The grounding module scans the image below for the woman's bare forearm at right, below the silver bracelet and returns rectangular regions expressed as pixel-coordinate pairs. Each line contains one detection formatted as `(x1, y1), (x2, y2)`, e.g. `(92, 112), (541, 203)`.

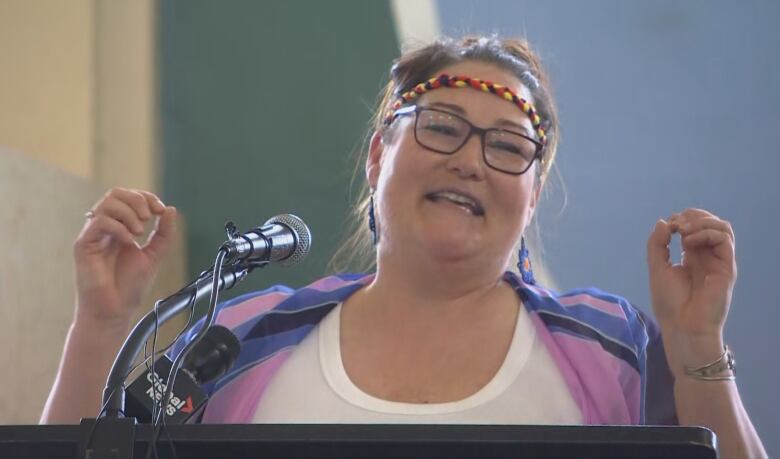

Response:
(674, 375), (768, 459)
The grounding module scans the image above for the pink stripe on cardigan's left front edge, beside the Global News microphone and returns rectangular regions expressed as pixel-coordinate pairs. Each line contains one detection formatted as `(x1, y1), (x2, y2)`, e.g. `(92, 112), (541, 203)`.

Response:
(203, 349), (292, 424)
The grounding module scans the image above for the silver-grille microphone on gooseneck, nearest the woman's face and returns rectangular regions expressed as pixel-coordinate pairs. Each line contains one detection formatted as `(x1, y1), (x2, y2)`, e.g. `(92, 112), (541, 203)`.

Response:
(222, 214), (311, 266)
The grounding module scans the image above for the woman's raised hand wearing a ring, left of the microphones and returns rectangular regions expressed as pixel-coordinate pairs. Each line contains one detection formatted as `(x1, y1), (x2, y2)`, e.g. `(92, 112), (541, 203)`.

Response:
(73, 188), (176, 323)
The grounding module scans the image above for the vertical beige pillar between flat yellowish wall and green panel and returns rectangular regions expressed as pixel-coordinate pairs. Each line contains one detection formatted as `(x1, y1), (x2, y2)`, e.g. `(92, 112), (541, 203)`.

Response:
(94, 0), (161, 190)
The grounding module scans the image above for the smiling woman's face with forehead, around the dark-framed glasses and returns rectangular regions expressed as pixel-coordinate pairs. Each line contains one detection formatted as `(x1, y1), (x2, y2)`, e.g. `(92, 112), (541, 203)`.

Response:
(366, 61), (539, 269)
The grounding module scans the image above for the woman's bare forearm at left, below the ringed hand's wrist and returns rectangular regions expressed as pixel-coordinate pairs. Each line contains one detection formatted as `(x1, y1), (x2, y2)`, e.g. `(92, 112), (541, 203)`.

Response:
(40, 318), (129, 424)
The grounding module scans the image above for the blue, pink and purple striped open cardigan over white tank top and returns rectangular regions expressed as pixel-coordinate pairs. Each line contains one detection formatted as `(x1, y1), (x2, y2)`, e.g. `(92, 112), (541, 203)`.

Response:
(172, 272), (676, 424)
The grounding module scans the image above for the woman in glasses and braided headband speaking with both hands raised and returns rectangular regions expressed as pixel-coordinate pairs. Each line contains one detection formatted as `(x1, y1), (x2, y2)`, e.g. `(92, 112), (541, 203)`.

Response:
(42, 38), (766, 457)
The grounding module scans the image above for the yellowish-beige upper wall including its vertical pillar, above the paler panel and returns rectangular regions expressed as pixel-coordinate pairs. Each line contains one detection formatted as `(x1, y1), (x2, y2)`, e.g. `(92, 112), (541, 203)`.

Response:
(0, 0), (158, 189)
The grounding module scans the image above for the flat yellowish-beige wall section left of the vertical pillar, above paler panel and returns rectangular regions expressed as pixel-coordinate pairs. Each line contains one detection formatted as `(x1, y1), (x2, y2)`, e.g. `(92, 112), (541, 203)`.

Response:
(0, 0), (95, 178)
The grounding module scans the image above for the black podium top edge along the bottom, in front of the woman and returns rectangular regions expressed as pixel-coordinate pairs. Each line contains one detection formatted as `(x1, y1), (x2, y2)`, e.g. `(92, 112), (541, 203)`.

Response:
(0, 424), (717, 459)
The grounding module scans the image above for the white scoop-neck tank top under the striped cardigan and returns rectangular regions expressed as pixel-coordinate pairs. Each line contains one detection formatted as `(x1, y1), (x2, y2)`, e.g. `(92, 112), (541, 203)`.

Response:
(254, 305), (582, 424)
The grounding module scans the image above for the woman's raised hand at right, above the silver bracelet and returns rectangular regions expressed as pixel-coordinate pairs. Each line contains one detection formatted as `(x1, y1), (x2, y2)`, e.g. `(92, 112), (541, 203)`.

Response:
(647, 209), (737, 372)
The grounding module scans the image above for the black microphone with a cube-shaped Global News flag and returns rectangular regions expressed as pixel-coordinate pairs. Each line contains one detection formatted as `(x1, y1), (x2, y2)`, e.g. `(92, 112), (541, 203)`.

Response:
(125, 325), (241, 424)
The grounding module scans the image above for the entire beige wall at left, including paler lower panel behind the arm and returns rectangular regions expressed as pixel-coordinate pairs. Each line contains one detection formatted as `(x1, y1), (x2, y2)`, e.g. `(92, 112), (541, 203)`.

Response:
(0, 0), (185, 424)
